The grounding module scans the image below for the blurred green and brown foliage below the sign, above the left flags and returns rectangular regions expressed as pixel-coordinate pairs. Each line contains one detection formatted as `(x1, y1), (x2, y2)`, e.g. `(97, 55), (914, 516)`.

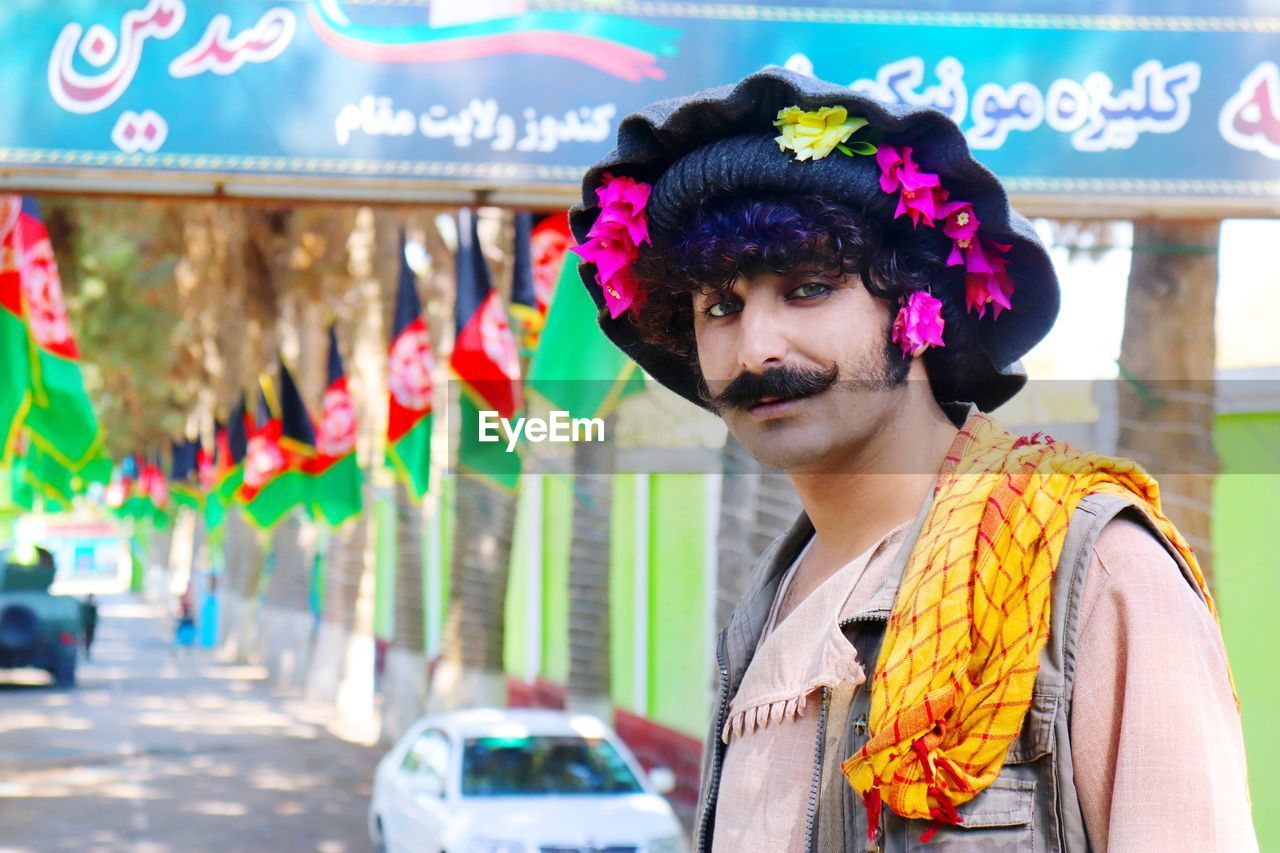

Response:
(41, 197), (355, 459)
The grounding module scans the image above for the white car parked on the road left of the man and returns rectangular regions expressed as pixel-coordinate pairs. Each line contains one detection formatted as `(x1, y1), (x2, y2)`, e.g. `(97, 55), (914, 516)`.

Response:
(369, 708), (687, 853)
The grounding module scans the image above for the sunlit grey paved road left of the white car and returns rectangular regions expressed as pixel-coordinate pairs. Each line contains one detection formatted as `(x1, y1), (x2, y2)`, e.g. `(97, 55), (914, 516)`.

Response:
(0, 598), (380, 853)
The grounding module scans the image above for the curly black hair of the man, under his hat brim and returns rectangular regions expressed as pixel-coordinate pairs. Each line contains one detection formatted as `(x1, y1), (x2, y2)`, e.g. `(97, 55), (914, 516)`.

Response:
(632, 195), (989, 402)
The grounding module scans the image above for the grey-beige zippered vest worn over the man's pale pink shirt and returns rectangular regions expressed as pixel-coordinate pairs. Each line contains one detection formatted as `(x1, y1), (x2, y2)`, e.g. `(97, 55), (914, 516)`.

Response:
(694, 468), (1194, 853)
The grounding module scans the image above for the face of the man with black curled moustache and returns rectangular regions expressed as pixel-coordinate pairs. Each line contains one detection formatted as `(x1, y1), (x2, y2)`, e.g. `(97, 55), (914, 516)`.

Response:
(692, 270), (920, 473)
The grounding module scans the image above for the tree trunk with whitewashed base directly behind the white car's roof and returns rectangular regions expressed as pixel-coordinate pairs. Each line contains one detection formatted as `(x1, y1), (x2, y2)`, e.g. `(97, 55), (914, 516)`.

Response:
(428, 473), (516, 711)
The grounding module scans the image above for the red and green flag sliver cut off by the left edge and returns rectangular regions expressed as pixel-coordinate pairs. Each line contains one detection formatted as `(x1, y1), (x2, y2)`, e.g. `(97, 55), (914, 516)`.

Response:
(0, 196), (31, 465)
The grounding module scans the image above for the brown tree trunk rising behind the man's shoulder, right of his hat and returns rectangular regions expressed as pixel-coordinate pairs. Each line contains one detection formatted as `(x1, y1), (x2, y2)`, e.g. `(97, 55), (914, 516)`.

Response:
(1119, 220), (1221, 576)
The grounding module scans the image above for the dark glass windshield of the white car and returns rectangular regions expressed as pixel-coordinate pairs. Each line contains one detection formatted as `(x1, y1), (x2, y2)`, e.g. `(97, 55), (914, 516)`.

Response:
(462, 735), (643, 797)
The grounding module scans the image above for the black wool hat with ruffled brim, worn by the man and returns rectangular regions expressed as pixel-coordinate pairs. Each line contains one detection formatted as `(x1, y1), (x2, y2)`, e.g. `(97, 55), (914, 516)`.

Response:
(570, 67), (1059, 411)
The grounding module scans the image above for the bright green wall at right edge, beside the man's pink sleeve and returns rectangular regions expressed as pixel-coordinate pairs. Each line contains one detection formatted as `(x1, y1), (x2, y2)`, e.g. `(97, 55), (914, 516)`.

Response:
(1212, 414), (1280, 850)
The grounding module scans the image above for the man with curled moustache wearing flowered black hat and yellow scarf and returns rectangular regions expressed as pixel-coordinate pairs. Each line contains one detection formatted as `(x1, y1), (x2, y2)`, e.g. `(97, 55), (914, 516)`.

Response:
(571, 68), (1257, 852)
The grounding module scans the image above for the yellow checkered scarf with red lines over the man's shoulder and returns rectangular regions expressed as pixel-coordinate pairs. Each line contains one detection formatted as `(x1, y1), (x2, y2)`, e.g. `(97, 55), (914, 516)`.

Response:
(842, 414), (1217, 835)
